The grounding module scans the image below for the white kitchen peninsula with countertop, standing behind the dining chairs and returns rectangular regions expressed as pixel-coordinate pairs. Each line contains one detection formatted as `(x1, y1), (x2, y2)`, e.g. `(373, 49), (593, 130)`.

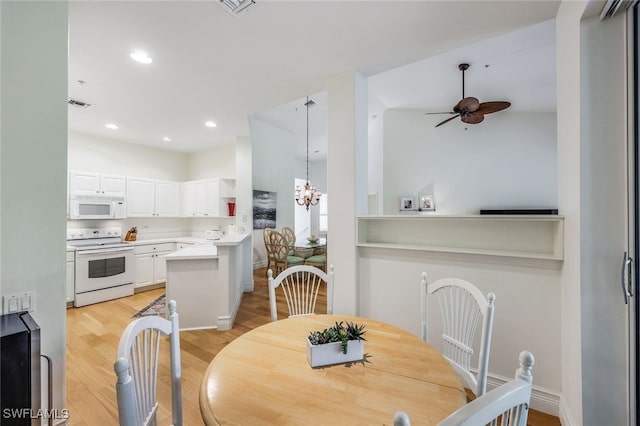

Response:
(166, 234), (253, 330)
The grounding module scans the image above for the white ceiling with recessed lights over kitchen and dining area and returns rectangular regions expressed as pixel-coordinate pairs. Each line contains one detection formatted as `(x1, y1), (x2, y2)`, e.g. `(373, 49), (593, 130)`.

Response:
(69, 0), (559, 152)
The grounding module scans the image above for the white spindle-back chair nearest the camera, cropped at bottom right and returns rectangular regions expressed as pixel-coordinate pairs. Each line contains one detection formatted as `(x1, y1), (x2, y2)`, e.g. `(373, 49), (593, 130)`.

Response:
(393, 351), (534, 426)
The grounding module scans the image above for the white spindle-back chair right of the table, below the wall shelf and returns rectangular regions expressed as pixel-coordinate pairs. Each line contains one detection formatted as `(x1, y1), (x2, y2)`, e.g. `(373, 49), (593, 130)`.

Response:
(420, 272), (496, 397)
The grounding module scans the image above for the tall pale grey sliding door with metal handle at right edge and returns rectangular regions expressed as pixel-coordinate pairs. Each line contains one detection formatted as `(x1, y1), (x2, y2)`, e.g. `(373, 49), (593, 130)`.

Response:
(580, 10), (635, 426)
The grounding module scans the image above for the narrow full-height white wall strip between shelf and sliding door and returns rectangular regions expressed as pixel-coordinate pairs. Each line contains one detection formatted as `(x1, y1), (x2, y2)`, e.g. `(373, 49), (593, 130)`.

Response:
(556, 1), (586, 426)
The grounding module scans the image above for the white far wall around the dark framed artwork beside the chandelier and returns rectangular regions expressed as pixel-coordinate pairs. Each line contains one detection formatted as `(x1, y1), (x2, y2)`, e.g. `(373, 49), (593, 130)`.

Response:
(249, 117), (296, 266)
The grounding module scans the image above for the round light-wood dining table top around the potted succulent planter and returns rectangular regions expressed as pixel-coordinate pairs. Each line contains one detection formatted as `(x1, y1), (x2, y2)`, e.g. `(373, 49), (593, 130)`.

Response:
(200, 315), (467, 425)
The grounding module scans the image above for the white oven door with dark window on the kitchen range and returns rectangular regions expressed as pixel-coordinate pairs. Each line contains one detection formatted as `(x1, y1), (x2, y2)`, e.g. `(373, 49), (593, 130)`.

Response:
(76, 247), (134, 293)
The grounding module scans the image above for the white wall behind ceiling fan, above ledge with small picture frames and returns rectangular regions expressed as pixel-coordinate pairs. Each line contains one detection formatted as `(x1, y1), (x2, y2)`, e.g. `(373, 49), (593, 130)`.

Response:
(383, 109), (558, 214)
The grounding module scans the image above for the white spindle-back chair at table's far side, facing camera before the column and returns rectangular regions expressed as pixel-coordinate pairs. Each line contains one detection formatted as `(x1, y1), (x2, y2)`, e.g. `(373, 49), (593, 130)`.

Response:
(267, 265), (334, 321)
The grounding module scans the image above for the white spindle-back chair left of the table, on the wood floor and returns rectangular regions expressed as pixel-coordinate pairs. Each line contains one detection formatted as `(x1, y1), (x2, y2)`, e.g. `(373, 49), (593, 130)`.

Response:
(114, 300), (182, 426)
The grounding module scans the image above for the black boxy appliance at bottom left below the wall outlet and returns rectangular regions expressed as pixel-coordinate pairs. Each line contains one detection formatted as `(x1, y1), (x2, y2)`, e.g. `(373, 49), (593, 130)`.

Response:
(0, 312), (40, 426)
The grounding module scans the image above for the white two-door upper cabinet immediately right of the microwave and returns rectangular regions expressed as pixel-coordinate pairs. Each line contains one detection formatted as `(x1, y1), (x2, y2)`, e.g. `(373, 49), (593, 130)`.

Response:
(127, 178), (180, 217)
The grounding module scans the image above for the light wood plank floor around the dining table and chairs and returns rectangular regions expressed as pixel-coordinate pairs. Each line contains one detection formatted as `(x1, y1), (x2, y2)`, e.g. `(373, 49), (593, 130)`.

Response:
(66, 269), (560, 426)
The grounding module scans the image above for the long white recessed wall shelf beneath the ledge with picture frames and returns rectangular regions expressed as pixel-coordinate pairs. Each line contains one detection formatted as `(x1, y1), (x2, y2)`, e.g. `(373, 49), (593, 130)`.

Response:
(356, 214), (564, 261)
